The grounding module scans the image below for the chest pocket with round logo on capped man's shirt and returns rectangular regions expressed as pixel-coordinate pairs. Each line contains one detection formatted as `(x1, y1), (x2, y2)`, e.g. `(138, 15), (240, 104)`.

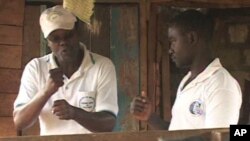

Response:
(79, 92), (96, 112)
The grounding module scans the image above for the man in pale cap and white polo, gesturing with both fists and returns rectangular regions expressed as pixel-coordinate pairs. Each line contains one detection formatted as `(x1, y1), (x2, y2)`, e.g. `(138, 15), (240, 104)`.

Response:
(13, 6), (118, 135)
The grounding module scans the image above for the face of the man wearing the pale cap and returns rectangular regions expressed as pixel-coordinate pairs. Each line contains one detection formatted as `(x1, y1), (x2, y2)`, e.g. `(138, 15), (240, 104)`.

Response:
(47, 29), (79, 62)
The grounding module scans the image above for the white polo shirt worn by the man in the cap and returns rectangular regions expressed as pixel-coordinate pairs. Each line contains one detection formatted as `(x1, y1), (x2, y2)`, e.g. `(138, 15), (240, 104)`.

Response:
(14, 44), (118, 135)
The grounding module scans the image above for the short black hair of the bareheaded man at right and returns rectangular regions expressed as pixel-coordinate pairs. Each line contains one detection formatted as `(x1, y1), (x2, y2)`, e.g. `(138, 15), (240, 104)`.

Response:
(168, 9), (214, 42)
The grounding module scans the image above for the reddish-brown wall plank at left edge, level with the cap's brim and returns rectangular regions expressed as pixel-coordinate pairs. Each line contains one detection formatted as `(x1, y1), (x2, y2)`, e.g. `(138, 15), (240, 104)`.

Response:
(0, 25), (23, 45)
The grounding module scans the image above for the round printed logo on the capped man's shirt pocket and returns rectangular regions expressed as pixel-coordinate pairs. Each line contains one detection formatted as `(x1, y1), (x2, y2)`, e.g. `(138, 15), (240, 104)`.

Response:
(79, 96), (95, 112)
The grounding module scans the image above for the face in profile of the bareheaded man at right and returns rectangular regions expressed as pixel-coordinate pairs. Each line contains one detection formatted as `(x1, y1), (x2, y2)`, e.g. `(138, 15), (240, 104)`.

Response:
(168, 27), (194, 68)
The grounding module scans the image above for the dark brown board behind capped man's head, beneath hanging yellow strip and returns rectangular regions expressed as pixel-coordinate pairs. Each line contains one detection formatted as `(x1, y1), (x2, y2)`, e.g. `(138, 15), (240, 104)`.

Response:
(80, 4), (110, 57)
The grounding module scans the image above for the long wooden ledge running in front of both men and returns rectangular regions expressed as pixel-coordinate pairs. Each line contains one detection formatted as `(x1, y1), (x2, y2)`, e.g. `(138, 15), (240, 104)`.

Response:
(0, 129), (229, 141)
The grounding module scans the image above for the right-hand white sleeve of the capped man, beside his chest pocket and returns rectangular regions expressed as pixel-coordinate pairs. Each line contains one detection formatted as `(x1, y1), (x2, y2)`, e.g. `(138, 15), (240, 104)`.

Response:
(95, 60), (118, 116)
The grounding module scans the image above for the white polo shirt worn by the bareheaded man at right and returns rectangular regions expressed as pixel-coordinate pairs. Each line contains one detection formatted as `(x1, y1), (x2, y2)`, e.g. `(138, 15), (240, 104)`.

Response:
(169, 58), (242, 130)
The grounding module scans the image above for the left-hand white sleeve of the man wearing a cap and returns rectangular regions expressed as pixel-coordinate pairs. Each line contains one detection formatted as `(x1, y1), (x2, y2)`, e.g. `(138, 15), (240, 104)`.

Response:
(14, 60), (38, 109)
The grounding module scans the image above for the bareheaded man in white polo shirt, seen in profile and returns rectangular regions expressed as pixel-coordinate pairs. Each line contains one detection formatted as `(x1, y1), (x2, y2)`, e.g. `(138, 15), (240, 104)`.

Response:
(131, 10), (242, 130)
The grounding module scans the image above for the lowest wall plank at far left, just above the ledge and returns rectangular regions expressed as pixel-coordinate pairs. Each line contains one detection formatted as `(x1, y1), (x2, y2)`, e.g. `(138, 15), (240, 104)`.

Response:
(0, 117), (16, 137)
